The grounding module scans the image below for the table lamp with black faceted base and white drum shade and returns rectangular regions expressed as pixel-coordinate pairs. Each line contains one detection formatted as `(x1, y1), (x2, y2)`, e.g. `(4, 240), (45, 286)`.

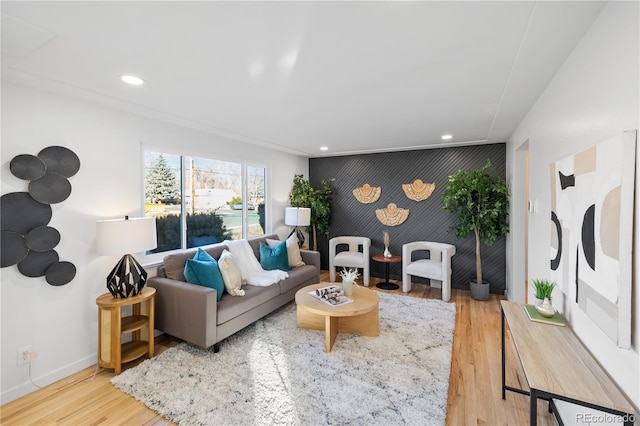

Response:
(96, 216), (158, 299)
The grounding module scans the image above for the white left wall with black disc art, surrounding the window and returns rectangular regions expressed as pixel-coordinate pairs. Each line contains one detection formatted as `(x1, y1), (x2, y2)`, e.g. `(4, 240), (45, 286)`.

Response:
(0, 83), (308, 404)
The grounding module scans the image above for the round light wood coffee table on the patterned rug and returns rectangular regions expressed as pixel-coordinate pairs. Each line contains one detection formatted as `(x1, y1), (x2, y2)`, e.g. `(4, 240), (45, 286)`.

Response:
(296, 283), (380, 352)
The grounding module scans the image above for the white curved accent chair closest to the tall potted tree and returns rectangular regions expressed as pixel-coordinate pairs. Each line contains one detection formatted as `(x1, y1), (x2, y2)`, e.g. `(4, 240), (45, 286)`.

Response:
(402, 241), (456, 302)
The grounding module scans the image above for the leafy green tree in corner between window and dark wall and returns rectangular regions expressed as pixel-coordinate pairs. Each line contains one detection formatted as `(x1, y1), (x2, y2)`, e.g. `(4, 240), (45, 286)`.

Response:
(289, 175), (335, 250)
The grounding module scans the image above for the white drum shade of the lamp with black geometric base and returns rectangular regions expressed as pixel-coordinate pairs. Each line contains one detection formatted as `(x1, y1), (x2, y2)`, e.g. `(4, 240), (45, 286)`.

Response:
(96, 217), (158, 256)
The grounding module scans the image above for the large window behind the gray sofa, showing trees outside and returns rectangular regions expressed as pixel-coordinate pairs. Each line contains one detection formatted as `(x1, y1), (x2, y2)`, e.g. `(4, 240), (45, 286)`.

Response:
(144, 151), (266, 253)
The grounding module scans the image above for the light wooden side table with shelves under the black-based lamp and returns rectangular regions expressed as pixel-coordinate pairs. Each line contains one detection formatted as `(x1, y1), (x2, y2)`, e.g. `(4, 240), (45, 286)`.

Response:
(96, 287), (156, 374)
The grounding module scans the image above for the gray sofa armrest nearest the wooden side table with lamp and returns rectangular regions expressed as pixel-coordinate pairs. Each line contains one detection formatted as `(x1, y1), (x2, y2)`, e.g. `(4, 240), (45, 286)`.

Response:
(147, 277), (218, 348)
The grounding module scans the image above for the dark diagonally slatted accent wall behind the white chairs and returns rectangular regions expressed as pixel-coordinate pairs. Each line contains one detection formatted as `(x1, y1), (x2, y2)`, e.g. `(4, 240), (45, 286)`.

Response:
(309, 144), (506, 294)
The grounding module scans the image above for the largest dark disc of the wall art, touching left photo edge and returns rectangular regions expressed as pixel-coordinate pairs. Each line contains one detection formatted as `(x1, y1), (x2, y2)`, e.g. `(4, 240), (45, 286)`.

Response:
(0, 192), (52, 235)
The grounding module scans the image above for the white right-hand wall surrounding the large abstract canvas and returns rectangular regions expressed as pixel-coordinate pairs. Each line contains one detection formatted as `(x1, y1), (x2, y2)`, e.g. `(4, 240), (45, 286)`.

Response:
(507, 1), (640, 405)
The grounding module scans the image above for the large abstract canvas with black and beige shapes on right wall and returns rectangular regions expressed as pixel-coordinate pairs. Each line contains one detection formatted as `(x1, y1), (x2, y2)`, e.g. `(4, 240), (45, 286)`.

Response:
(550, 131), (637, 348)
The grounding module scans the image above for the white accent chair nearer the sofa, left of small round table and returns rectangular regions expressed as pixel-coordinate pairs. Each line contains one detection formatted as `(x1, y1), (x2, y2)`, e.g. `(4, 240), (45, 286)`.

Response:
(329, 237), (371, 287)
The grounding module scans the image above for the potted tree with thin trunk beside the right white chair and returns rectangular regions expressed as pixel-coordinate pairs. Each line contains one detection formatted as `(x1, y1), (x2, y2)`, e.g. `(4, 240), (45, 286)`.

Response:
(442, 161), (509, 300)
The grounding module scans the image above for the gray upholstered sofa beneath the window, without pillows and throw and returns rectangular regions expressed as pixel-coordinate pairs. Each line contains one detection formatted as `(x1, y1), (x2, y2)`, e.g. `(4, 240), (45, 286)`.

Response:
(147, 235), (320, 352)
